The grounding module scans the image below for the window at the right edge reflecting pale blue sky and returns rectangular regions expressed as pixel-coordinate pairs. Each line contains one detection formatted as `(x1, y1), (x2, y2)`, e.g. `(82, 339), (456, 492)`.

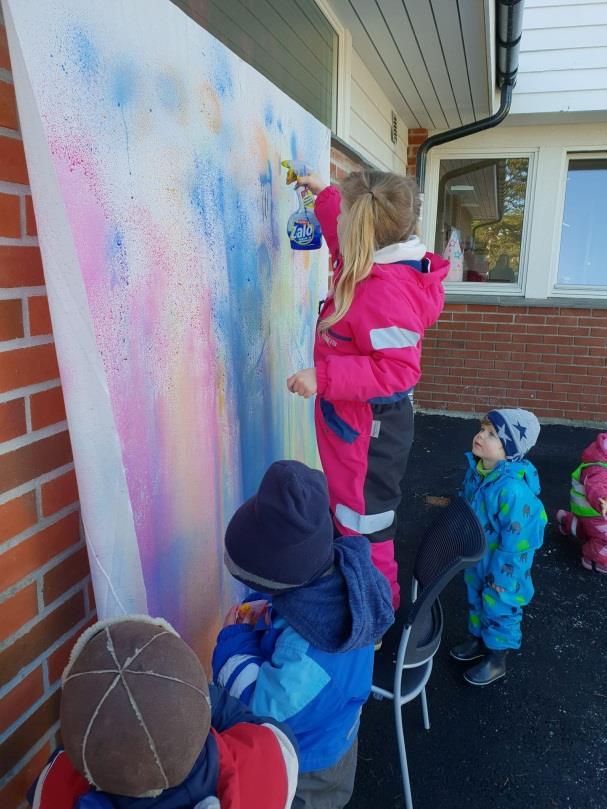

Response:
(557, 157), (607, 289)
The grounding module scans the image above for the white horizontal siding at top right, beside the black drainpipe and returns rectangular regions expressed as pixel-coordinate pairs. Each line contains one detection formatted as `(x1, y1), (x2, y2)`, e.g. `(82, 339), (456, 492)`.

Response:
(512, 0), (607, 115)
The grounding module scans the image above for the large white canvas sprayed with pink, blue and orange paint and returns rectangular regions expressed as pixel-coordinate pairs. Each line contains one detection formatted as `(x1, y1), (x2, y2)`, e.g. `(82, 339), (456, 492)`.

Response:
(3, 0), (330, 656)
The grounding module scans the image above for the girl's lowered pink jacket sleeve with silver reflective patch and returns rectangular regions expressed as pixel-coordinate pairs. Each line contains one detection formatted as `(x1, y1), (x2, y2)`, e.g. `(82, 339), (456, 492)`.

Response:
(316, 279), (424, 402)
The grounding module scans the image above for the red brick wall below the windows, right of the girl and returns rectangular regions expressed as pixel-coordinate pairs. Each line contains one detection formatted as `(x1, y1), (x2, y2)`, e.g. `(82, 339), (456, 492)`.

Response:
(415, 303), (607, 425)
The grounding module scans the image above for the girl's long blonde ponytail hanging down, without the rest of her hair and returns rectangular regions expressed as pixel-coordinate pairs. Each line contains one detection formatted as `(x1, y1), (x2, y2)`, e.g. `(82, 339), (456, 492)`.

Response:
(318, 191), (376, 331)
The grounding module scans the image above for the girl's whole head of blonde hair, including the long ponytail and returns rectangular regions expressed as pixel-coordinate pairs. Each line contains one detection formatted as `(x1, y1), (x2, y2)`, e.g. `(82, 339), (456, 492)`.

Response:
(318, 170), (421, 331)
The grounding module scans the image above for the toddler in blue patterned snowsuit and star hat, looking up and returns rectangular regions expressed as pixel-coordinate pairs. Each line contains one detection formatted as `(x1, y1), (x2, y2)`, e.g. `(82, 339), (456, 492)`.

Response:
(451, 408), (547, 685)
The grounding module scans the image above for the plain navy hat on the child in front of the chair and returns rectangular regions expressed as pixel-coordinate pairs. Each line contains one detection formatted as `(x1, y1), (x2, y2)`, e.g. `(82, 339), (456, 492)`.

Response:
(225, 461), (333, 593)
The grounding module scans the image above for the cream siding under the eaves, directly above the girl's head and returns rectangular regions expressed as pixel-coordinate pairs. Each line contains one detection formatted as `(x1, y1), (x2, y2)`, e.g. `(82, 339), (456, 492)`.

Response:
(347, 50), (407, 173)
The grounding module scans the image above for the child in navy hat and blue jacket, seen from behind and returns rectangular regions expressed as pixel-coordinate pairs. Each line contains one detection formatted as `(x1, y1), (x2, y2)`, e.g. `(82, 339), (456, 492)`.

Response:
(213, 461), (394, 809)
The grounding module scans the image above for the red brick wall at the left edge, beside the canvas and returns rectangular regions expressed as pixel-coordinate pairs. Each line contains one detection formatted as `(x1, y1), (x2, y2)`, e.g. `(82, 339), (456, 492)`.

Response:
(0, 26), (94, 809)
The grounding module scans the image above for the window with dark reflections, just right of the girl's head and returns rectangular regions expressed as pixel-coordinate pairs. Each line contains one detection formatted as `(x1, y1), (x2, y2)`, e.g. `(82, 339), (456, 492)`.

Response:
(434, 157), (529, 291)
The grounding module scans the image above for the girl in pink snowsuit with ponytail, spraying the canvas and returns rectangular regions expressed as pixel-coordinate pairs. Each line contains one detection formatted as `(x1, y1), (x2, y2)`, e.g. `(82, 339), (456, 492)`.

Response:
(287, 171), (449, 608)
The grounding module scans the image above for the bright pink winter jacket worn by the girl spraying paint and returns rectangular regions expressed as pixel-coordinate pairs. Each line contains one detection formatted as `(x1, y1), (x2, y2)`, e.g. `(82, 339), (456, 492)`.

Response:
(314, 186), (449, 402)
